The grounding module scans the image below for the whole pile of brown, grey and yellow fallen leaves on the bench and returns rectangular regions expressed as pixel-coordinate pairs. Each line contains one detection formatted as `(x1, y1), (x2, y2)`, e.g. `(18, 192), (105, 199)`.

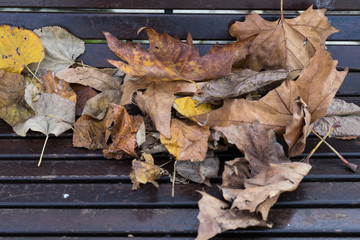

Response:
(0, 7), (360, 239)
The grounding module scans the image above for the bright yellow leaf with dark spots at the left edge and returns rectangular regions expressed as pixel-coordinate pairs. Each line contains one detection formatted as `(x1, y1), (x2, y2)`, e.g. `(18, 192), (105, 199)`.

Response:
(0, 25), (45, 74)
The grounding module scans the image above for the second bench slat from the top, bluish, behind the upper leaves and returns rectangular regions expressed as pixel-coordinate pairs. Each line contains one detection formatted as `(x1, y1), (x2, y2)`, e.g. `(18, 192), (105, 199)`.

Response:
(0, 12), (360, 41)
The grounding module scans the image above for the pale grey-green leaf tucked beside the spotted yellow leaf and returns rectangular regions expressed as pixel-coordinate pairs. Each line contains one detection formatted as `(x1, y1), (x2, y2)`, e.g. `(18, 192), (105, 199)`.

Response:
(30, 26), (85, 73)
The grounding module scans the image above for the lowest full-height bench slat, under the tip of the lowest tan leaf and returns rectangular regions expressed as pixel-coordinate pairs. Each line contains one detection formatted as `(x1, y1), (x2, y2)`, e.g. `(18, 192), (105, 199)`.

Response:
(0, 208), (360, 237)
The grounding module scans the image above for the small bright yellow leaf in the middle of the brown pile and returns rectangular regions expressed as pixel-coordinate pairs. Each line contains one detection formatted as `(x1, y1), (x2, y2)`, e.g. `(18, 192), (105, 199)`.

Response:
(174, 97), (215, 117)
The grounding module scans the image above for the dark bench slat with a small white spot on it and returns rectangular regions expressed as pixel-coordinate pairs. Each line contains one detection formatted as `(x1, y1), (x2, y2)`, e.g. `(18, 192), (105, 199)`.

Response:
(0, 182), (360, 208)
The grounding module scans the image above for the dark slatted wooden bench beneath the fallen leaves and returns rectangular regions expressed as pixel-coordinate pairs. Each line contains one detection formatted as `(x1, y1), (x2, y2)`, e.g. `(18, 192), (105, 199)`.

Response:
(0, 0), (360, 240)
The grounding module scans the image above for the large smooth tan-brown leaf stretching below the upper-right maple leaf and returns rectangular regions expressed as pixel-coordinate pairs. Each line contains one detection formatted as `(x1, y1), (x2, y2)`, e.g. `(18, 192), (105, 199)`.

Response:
(194, 47), (347, 158)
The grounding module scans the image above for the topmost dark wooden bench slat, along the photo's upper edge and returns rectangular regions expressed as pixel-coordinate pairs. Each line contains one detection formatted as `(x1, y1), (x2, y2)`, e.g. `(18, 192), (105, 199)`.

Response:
(0, 0), (360, 10)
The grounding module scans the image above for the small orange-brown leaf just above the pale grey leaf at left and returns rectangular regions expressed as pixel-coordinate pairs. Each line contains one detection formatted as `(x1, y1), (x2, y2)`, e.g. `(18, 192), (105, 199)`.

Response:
(41, 71), (76, 104)
